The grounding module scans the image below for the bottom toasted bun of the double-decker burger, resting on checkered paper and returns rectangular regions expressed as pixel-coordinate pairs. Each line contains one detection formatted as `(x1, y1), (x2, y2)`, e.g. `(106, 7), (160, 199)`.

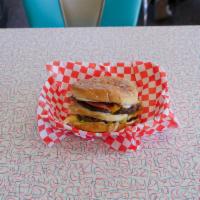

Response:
(64, 115), (138, 133)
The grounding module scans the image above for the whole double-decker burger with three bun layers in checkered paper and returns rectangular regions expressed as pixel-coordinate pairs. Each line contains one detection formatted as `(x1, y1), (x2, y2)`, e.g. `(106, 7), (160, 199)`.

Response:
(65, 76), (141, 133)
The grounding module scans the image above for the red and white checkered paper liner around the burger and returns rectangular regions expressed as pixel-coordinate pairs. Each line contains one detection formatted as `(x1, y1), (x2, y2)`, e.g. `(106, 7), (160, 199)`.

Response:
(37, 61), (178, 152)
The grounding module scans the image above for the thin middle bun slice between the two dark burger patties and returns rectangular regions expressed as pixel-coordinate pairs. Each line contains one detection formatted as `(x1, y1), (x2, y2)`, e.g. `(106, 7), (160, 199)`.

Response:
(69, 103), (128, 122)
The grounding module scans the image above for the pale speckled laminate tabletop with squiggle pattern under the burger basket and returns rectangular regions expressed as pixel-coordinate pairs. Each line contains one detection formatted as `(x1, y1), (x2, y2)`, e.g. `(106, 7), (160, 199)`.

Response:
(0, 26), (200, 200)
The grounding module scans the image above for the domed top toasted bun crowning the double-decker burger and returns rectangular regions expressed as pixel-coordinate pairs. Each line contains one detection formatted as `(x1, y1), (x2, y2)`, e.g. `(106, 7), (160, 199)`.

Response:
(72, 76), (138, 106)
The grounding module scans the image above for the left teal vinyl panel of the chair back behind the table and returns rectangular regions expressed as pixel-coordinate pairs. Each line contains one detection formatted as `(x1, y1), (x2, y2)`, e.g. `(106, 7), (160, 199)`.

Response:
(23, 0), (65, 28)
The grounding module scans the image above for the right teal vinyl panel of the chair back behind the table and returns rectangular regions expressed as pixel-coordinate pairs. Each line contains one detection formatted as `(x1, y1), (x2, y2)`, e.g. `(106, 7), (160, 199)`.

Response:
(99, 0), (142, 26)
